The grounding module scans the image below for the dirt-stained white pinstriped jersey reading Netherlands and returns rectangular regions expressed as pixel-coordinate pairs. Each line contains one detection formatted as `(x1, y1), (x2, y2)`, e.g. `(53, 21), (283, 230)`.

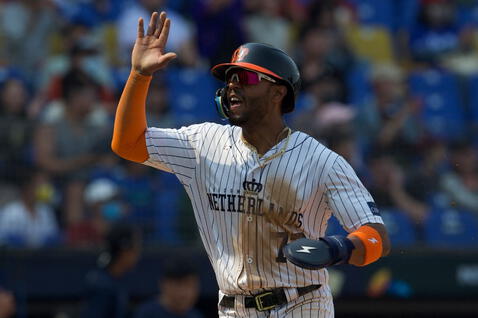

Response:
(144, 123), (383, 296)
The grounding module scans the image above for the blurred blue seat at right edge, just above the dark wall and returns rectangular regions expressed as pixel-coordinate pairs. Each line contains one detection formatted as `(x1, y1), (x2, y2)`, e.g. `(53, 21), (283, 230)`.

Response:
(425, 208), (478, 248)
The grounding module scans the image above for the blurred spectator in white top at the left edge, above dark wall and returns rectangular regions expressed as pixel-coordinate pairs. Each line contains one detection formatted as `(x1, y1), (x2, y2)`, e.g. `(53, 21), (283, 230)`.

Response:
(0, 167), (60, 247)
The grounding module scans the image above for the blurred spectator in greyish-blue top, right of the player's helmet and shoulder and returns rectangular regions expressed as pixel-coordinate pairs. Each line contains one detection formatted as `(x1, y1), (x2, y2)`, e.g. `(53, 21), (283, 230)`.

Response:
(356, 64), (423, 162)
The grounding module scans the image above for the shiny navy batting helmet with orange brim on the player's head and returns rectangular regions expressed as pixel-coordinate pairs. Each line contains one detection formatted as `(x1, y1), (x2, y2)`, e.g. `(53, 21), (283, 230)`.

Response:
(211, 43), (300, 113)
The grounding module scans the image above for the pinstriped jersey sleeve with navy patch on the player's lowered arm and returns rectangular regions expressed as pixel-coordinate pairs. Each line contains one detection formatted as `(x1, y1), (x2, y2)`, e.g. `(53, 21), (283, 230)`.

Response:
(325, 156), (383, 232)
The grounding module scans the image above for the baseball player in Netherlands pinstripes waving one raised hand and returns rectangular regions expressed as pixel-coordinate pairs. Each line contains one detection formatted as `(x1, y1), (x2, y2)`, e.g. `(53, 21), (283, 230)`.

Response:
(112, 12), (390, 317)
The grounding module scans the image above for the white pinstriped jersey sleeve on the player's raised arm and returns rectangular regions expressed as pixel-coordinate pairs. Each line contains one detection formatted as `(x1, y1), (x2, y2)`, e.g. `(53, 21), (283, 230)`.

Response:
(143, 124), (203, 184)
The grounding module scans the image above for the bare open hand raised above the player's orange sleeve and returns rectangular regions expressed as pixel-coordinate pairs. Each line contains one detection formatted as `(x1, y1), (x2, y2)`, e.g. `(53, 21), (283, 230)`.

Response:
(131, 12), (176, 75)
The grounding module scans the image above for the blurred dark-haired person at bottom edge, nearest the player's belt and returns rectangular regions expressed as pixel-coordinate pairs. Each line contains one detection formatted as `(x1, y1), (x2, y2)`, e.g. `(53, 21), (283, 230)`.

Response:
(135, 255), (203, 318)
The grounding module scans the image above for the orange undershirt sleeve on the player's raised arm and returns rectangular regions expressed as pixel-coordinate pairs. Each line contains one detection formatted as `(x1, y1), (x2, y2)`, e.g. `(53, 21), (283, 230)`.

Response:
(111, 70), (152, 162)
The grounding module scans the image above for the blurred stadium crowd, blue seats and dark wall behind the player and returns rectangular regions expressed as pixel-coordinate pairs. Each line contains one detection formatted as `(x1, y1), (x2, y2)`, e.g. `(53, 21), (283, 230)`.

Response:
(0, 0), (478, 318)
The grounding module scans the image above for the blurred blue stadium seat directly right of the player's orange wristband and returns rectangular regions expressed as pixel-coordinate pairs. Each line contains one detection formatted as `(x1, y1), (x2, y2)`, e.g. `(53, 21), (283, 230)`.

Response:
(381, 209), (417, 246)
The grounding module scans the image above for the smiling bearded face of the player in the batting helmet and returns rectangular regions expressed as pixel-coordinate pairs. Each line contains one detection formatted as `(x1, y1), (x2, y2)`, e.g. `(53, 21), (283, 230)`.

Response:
(226, 69), (274, 127)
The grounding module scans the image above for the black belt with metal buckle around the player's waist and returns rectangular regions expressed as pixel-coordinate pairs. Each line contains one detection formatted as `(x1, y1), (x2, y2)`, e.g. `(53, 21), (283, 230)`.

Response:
(219, 285), (321, 311)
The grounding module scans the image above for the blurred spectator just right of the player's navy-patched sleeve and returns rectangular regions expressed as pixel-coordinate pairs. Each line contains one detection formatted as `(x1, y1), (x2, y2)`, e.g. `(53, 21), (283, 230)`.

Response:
(365, 149), (429, 229)
